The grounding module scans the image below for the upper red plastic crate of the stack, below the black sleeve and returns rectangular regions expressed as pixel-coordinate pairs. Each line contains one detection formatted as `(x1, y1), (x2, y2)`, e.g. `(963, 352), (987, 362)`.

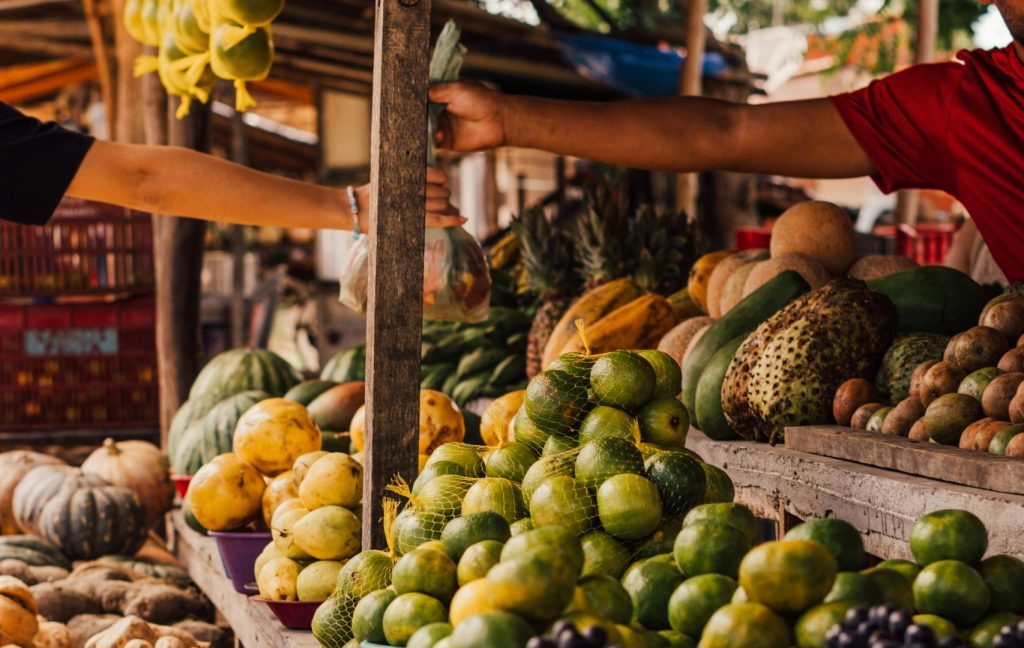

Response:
(0, 198), (154, 298)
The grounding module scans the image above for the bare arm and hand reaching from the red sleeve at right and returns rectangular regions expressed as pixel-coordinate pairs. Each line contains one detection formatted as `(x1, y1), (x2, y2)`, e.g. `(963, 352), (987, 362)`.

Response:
(430, 83), (873, 178)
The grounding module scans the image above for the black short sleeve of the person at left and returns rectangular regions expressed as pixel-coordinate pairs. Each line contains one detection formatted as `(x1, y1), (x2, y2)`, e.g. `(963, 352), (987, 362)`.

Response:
(0, 101), (93, 225)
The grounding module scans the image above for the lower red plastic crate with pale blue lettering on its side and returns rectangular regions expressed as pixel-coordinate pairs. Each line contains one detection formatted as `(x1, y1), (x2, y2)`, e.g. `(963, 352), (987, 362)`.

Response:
(0, 297), (160, 431)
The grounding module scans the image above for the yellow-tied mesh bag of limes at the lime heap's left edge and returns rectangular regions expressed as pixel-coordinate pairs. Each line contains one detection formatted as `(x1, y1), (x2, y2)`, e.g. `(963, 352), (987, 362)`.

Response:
(311, 499), (398, 648)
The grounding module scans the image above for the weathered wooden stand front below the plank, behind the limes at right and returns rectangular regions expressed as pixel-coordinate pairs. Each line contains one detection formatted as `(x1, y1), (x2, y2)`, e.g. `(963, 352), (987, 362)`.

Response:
(686, 428), (1024, 558)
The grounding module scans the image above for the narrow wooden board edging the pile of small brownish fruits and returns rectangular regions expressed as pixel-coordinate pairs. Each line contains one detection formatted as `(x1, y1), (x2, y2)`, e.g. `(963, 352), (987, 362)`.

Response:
(785, 426), (1024, 494)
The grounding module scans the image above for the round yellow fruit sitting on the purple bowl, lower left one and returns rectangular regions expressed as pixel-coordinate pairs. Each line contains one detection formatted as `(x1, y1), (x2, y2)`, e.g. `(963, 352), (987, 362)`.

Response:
(185, 452), (266, 531)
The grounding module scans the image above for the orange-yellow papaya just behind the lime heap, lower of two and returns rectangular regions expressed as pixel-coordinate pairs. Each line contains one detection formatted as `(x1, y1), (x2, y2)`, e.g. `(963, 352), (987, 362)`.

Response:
(559, 295), (677, 355)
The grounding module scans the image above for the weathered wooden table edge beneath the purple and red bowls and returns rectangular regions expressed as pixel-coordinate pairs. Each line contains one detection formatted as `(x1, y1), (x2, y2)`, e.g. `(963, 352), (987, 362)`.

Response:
(167, 510), (319, 648)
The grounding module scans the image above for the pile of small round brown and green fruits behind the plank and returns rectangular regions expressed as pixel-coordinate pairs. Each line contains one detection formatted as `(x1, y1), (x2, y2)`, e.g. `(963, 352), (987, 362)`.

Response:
(833, 284), (1024, 457)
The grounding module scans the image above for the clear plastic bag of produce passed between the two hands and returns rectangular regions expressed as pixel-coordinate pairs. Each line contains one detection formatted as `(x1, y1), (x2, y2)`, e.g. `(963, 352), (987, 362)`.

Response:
(340, 20), (490, 323)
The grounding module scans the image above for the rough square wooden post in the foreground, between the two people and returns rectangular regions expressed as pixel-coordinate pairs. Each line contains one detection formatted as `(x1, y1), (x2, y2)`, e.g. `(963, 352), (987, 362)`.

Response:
(362, 0), (430, 549)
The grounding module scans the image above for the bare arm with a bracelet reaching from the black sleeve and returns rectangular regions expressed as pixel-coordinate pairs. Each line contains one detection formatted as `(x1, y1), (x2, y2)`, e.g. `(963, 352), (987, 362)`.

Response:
(67, 141), (464, 231)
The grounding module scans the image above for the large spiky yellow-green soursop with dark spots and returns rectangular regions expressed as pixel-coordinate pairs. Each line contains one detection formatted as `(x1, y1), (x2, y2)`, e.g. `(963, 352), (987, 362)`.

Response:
(722, 278), (896, 441)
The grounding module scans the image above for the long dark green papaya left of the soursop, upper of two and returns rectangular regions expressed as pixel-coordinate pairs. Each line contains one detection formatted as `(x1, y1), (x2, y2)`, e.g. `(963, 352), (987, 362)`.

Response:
(682, 270), (810, 412)
